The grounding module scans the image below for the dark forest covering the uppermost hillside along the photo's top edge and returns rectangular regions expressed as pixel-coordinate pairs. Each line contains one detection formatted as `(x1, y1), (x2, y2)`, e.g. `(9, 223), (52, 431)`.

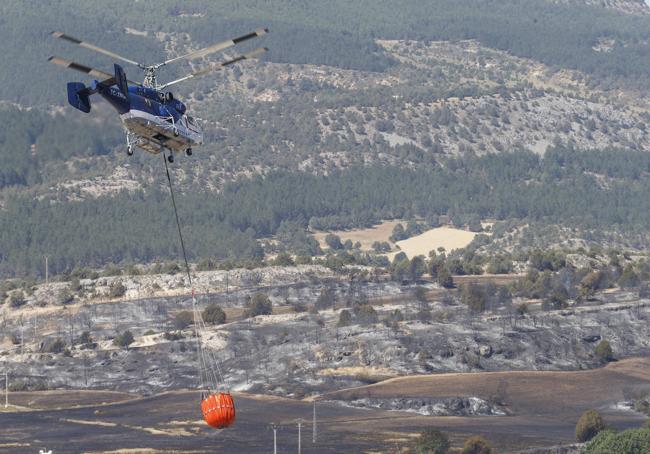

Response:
(0, 0), (650, 104)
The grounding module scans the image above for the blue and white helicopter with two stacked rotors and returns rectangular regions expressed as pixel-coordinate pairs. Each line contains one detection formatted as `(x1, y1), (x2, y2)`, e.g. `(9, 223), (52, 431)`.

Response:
(48, 28), (268, 163)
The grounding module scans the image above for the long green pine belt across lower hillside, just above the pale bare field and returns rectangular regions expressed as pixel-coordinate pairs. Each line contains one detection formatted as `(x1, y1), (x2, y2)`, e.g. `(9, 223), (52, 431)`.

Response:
(0, 147), (650, 276)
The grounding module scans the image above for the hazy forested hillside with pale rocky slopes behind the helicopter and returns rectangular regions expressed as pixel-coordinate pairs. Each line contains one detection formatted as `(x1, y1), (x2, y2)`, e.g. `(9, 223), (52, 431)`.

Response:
(0, 0), (650, 276)
